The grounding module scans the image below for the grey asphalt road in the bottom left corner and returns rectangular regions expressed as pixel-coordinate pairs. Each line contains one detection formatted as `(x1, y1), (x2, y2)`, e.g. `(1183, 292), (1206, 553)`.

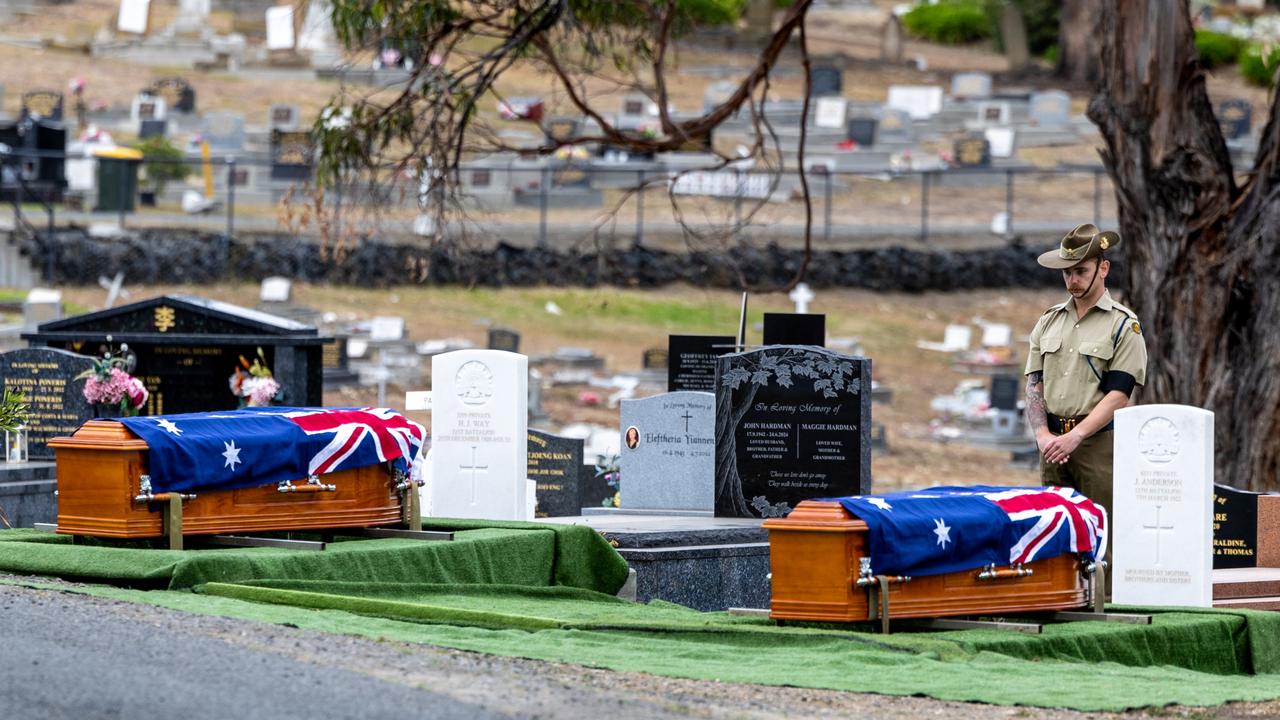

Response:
(0, 589), (507, 720)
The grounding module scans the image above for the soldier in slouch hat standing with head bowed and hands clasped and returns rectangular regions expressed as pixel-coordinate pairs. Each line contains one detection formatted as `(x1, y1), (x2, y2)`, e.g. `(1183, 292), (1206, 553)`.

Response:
(1027, 223), (1147, 520)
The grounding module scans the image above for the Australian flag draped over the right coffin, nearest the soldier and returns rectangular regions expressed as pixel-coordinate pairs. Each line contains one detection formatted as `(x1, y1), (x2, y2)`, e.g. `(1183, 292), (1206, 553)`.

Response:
(831, 486), (1107, 575)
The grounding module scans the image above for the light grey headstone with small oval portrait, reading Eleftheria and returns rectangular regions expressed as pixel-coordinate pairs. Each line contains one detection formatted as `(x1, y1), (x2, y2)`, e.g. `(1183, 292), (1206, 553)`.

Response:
(620, 392), (716, 512)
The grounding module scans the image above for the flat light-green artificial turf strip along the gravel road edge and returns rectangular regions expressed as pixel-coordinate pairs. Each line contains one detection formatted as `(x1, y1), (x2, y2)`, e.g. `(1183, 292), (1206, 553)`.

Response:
(10, 573), (1280, 711)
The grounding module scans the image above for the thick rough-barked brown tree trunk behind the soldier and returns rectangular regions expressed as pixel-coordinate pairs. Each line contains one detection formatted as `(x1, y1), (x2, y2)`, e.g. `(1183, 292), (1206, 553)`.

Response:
(1090, 0), (1280, 489)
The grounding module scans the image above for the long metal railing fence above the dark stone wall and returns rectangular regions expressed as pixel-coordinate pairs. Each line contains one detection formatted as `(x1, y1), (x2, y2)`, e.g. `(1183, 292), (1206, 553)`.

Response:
(0, 151), (1116, 249)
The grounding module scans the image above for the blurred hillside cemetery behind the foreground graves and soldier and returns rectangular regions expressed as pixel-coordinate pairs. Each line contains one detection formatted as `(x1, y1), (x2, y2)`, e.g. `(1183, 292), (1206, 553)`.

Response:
(0, 0), (1264, 489)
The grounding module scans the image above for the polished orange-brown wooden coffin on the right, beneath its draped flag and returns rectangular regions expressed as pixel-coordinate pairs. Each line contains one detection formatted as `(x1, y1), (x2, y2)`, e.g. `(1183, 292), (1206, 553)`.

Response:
(764, 500), (1088, 623)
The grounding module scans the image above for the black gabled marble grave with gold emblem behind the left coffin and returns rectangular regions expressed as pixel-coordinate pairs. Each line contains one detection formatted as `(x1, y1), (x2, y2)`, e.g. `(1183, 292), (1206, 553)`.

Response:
(22, 295), (333, 415)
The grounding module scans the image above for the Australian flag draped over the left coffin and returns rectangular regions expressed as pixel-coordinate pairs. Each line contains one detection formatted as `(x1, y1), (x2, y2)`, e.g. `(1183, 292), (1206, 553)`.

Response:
(120, 407), (426, 492)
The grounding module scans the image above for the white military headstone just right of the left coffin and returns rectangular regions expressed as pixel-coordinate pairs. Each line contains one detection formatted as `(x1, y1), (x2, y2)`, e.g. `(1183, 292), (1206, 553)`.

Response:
(425, 350), (532, 520)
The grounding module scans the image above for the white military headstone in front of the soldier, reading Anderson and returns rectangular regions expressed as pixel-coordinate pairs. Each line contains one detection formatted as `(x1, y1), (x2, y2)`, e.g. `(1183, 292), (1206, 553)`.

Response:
(1108, 405), (1213, 607)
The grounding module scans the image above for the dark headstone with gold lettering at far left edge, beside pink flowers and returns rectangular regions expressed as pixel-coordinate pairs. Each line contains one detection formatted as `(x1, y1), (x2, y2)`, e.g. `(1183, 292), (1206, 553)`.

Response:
(0, 347), (93, 460)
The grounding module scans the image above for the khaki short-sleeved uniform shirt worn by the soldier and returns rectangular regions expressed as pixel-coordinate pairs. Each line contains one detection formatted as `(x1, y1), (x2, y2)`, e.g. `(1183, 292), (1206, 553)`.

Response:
(1027, 292), (1147, 418)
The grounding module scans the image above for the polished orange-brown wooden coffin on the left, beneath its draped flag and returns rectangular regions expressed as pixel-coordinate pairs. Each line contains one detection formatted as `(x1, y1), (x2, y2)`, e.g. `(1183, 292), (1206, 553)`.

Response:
(49, 420), (416, 538)
